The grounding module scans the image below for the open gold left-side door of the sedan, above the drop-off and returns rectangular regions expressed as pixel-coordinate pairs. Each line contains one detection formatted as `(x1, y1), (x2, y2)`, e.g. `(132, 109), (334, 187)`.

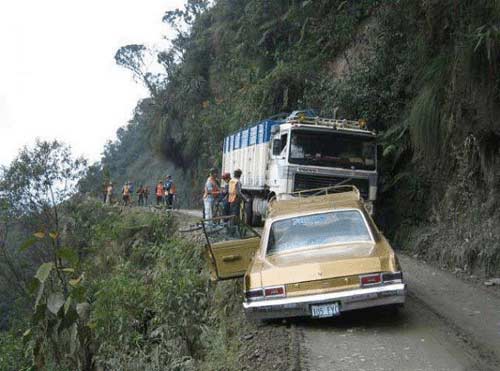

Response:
(203, 220), (260, 280)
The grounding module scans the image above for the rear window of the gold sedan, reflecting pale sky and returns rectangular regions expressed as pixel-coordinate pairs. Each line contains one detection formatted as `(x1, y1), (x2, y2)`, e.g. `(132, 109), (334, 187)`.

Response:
(267, 210), (372, 255)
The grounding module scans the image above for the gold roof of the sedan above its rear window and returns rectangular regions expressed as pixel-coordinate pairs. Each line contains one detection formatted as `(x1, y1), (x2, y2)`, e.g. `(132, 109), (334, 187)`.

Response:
(268, 187), (364, 219)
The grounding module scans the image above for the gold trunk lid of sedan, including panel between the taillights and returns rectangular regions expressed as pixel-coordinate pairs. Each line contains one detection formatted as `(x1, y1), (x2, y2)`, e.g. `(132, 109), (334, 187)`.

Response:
(261, 243), (389, 296)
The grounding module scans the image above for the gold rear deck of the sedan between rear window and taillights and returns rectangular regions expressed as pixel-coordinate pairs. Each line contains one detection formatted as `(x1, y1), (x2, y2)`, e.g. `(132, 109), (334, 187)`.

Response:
(260, 243), (391, 286)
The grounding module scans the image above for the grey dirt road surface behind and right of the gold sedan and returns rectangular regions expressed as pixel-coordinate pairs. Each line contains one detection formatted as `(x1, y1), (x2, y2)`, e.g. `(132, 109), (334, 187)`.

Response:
(296, 256), (500, 371)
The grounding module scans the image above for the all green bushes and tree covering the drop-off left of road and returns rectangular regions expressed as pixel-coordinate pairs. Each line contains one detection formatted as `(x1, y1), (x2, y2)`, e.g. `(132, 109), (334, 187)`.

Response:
(0, 142), (247, 370)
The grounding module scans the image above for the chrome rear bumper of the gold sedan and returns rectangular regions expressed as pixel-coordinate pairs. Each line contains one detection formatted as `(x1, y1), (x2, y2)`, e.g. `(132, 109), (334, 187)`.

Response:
(243, 283), (406, 320)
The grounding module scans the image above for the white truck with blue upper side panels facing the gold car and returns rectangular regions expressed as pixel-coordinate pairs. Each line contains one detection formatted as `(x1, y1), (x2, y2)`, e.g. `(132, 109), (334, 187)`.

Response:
(222, 111), (378, 224)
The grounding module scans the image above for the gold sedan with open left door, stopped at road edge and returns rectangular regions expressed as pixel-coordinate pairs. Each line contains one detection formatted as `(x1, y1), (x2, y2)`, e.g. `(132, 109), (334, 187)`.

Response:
(205, 187), (406, 319)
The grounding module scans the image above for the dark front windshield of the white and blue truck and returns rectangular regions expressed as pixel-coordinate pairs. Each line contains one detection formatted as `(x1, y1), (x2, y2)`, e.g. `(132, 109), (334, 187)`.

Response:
(289, 130), (376, 170)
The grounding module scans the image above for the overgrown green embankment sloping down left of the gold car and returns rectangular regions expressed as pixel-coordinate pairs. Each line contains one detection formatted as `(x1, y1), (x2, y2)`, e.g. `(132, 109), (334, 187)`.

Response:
(0, 199), (298, 371)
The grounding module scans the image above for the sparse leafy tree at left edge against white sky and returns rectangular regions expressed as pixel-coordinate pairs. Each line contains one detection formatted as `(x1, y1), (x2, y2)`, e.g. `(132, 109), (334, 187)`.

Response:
(0, 140), (86, 304)
